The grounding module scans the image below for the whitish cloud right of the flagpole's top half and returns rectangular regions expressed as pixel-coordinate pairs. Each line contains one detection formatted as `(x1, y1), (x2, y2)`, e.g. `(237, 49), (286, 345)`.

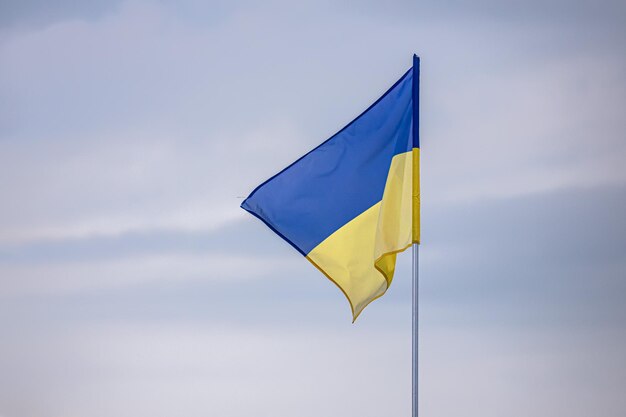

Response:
(422, 43), (626, 203)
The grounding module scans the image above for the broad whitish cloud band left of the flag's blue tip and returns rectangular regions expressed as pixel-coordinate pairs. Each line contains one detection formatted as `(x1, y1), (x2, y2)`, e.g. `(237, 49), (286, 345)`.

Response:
(0, 118), (299, 243)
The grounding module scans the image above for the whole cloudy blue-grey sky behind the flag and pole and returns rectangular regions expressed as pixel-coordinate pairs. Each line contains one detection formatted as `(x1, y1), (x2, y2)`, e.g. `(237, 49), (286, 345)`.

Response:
(0, 0), (626, 417)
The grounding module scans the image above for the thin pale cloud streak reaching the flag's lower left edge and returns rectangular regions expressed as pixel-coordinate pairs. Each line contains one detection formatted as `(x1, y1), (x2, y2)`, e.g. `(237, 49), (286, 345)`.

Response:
(0, 253), (303, 297)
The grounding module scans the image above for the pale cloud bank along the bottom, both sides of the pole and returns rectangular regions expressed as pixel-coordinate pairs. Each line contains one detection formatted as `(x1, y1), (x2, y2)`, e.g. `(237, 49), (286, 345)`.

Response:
(0, 316), (626, 417)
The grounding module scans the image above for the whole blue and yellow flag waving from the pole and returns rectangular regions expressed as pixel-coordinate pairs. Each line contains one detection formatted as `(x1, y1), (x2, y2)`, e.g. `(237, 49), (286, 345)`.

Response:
(241, 56), (420, 320)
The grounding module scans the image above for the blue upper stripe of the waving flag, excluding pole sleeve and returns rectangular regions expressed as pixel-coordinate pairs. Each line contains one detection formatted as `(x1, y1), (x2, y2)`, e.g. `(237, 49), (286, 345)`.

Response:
(241, 69), (413, 255)
